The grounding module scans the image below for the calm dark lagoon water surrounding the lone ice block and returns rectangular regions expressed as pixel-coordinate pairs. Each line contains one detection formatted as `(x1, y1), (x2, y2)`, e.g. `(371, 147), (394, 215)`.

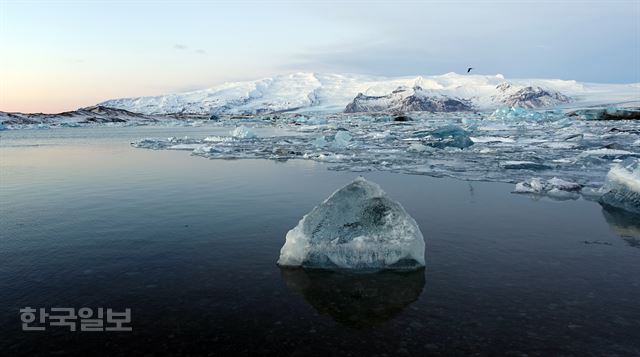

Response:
(0, 128), (640, 356)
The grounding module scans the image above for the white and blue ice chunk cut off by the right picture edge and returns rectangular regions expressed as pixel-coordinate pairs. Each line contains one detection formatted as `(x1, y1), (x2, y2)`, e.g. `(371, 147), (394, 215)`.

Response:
(600, 159), (640, 213)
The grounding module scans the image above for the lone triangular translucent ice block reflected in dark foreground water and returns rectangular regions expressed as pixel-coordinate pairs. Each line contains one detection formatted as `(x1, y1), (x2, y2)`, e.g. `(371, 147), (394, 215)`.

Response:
(278, 177), (425, 270)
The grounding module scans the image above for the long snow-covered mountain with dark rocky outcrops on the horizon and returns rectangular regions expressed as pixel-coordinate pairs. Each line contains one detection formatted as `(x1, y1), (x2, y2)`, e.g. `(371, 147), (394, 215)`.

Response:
(100, 73), (640, 114)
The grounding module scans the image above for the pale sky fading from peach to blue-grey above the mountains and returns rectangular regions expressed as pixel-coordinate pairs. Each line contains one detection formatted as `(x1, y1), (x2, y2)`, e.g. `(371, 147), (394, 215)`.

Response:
(0, 0), (640, 112)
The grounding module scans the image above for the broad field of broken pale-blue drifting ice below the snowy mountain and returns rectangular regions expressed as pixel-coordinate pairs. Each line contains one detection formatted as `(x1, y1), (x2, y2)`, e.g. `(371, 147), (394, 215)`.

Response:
(132, 111), (640, 188)
